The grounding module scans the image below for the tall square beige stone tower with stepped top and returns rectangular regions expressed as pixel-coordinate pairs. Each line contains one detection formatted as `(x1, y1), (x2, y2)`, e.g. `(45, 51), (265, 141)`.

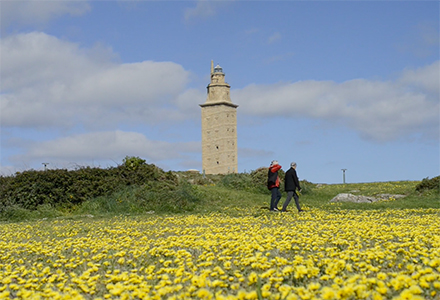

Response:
(200, 61), (238, 174)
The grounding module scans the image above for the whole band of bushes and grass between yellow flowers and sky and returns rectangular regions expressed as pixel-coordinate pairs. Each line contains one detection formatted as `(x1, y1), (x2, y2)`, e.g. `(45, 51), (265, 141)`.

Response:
(0, 157), (440, 221)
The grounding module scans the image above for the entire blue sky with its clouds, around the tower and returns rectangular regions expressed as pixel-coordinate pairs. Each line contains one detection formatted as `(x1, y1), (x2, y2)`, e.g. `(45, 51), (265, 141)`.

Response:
(0, 1), (440, 183)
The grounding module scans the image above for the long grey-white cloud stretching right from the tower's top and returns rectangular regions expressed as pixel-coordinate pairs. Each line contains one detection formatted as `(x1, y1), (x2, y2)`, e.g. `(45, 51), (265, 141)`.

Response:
(232, 62), (440, 141)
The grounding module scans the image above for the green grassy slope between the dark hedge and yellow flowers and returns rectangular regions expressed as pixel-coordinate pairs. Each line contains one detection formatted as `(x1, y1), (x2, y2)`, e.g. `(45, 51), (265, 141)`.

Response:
(0, 175), (440, 222)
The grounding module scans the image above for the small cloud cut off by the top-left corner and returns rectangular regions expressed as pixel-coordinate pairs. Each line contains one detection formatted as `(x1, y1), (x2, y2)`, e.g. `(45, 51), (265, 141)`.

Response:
(0, 0), (91, 29)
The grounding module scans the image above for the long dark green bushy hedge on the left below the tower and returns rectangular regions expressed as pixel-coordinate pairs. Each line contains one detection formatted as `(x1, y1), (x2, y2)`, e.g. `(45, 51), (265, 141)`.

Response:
(0, 157), (178, 213)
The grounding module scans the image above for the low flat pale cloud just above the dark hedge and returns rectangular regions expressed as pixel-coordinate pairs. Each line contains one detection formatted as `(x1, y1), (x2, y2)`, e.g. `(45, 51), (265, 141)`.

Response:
(10, 130), (201, 166)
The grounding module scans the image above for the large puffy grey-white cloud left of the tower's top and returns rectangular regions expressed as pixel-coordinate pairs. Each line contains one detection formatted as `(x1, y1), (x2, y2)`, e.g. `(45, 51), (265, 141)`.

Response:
(0, 32), (190, 128)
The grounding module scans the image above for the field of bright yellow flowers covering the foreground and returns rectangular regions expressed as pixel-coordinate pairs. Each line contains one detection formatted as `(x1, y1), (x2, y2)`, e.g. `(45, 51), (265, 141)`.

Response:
(0, 208), (440, 299)
